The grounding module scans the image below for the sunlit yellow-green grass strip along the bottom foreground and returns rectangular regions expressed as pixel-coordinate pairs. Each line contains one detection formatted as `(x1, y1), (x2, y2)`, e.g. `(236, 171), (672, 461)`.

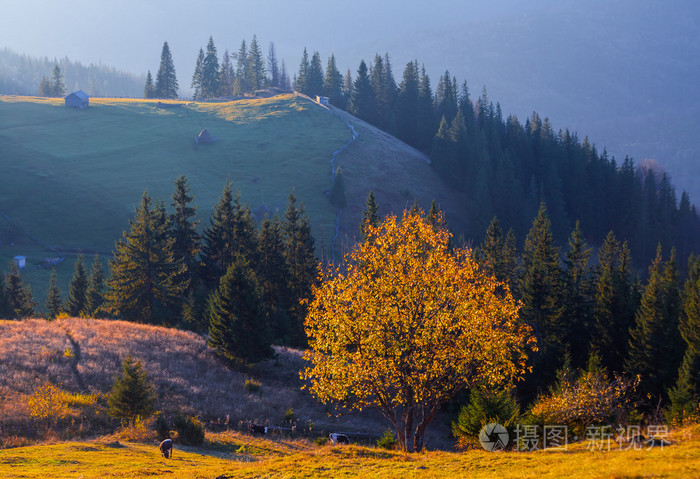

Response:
(0, 427), (700, 479)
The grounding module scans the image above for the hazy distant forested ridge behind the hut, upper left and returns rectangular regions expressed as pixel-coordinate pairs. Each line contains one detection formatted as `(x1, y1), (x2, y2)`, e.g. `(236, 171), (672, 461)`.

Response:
(0, 48), (145, 97)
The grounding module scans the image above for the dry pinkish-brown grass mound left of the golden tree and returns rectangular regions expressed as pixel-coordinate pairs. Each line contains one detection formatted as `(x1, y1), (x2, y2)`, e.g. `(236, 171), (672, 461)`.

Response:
(0, 318), (452, 447)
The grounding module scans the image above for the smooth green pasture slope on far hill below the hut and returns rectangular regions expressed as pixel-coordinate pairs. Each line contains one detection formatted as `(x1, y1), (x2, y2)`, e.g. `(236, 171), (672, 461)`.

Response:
(0, 95), (350, 303)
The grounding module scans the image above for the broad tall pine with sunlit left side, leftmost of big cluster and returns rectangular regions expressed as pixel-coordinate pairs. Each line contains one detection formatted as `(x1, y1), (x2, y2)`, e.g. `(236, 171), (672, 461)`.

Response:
(105, 192), (189, 324)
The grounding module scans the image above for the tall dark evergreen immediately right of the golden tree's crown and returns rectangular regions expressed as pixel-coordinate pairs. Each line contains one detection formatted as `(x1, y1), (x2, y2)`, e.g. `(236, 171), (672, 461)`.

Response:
(519, 203), (565, 394)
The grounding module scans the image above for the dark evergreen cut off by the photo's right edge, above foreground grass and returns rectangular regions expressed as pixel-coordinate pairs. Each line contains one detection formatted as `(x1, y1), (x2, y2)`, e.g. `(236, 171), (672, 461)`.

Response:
(668, 255), (700, 422)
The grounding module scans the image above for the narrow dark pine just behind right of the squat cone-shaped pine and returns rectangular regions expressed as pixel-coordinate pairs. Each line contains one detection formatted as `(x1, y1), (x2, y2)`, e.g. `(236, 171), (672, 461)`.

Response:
(256, 216), (291, 344)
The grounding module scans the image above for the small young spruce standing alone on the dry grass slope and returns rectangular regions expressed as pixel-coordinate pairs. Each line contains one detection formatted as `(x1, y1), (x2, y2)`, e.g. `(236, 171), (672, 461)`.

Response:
(107, 355), (156, 425)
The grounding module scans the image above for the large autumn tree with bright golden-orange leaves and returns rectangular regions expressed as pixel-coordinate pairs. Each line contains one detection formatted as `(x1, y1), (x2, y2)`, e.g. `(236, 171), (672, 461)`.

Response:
(301, 211), (534, 451)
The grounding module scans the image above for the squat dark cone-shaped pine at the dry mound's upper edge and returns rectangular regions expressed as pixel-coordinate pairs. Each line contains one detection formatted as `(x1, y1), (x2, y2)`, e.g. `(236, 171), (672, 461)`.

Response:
(207, 255), (273, 364)
